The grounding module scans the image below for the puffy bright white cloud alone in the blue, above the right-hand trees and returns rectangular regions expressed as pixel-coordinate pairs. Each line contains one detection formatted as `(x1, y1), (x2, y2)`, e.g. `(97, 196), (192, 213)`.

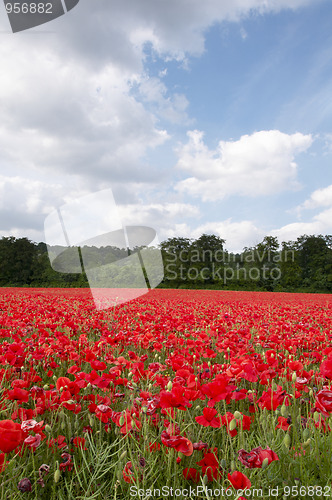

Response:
(176, 130), (313, 201)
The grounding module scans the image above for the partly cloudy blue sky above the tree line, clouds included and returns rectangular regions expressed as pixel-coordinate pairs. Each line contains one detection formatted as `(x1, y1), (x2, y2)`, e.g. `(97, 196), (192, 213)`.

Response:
(0, 0), (332, 251)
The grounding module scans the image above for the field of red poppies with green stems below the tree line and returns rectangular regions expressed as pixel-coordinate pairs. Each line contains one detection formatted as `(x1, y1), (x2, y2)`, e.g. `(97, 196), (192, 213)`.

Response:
(0, 288), (332, 500)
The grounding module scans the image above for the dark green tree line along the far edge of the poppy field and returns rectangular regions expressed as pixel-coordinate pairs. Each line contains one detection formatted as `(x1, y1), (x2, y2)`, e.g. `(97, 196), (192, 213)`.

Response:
(0, 234), (332, 293)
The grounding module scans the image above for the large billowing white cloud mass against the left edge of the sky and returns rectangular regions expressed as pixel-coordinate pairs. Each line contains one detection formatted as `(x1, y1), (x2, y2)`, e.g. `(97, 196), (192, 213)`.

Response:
(0, 41), (168, 181)
